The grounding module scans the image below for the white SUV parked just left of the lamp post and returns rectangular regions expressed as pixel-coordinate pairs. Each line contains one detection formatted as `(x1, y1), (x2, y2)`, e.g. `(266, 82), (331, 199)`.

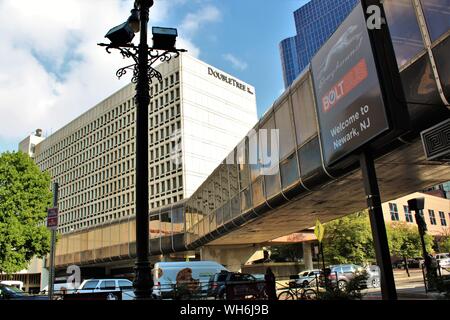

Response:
(76, 279), (135, 300)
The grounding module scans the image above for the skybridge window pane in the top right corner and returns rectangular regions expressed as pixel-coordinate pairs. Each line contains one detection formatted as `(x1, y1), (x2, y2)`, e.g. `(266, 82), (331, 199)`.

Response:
(421, 0), (450, 41)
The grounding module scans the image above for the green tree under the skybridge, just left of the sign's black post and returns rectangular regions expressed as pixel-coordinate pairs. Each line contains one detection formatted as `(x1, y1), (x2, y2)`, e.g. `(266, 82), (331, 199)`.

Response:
(323, 211), (375, 264)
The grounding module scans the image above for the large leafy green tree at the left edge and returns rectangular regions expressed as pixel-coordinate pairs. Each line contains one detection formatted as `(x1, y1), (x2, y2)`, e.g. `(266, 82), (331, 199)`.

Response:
(0, 152), (52, 273)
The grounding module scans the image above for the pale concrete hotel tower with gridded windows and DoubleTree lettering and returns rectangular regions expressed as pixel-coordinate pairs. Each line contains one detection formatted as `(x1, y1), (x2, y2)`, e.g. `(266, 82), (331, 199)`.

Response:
(19, 54), (257, 233)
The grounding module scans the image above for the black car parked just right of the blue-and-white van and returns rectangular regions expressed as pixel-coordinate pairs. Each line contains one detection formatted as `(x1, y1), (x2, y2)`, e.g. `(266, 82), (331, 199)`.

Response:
(208, 271), (264, 299)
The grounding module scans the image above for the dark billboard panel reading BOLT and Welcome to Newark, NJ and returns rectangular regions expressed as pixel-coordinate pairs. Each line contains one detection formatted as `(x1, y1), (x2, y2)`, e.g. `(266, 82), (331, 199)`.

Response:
(311, 4), (389, 165)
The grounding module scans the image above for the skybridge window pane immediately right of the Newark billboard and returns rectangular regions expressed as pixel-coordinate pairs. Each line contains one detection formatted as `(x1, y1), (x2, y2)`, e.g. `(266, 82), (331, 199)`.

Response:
(384, 0), (428, 67)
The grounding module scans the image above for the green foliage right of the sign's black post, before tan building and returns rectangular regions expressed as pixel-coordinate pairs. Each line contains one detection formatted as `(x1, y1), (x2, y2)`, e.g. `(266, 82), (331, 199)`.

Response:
(386, 222), (433, 258)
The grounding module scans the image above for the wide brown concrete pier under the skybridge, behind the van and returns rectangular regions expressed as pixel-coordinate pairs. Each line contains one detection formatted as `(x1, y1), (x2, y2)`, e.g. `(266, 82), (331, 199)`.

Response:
(200, 245), (264, 272)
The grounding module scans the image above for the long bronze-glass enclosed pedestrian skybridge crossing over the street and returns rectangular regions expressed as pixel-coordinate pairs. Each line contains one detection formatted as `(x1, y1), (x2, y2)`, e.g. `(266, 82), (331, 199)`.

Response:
(56, 0), (450, 267)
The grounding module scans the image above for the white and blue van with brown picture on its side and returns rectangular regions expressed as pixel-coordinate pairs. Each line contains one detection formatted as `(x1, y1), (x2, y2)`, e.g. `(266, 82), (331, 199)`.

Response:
(152, 261), (228, 299)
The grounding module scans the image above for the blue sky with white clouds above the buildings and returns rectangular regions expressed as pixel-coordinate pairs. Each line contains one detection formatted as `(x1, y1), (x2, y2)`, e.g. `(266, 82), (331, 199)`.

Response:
(0, 0), (307, 152)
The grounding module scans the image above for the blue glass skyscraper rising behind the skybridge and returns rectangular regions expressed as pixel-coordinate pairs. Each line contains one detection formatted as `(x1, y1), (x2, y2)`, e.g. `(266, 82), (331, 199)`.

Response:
(280, 0), (359, 88)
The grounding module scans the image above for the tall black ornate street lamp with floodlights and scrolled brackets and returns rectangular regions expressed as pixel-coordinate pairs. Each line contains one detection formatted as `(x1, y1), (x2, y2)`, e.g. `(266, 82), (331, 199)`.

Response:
(98, 0), (186, 299)
